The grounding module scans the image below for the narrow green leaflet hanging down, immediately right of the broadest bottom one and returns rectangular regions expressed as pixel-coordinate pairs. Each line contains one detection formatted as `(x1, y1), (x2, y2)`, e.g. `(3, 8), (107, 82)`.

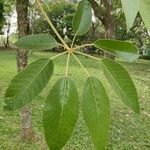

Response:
(82, 77), (110, 150)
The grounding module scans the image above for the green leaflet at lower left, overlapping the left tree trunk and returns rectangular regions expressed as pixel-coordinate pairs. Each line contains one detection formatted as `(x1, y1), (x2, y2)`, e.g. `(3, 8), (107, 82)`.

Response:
(5, 58), (54, 110)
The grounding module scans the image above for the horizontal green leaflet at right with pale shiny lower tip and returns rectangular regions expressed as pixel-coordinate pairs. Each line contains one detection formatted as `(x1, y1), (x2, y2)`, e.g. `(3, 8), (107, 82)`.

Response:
(94, 40), (139, 62)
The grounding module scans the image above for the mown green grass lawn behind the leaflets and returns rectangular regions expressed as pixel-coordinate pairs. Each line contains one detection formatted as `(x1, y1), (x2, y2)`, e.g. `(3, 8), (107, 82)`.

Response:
(0, 50), (150, 150)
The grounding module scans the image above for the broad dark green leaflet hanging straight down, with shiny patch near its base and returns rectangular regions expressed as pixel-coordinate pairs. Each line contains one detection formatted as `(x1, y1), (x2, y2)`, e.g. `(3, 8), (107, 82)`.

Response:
(43, 77), (79, 150)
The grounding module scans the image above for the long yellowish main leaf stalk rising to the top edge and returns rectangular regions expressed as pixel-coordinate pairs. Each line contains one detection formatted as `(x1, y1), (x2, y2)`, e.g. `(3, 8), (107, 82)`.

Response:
(35, 0), (69, 49)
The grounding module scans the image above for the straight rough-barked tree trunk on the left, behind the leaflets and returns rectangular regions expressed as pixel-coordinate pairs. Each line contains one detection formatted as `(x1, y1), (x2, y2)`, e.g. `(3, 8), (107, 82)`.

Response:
(16, 0), (35, 141)
